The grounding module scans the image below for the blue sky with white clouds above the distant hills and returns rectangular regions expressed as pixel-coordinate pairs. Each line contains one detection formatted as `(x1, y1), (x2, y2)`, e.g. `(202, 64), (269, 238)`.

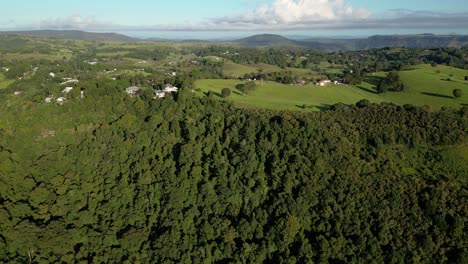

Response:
(0, 0), (468, 39)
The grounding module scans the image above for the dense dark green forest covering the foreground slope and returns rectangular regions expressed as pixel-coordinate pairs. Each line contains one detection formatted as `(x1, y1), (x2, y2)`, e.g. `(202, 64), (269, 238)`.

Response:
(0, 86), (468, 263)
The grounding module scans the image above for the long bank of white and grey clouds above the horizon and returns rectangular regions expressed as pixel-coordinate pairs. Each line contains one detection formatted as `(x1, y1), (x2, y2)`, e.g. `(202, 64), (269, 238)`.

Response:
(3, 0), (468, 32)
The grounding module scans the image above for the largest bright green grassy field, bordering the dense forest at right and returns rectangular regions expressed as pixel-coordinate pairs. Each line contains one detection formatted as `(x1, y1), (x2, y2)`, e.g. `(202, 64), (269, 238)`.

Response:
(196, 65), (468, 111)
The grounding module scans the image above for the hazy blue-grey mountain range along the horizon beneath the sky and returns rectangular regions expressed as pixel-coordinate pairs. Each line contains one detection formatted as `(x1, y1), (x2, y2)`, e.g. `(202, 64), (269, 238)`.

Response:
(0, 30), (468, 51)
